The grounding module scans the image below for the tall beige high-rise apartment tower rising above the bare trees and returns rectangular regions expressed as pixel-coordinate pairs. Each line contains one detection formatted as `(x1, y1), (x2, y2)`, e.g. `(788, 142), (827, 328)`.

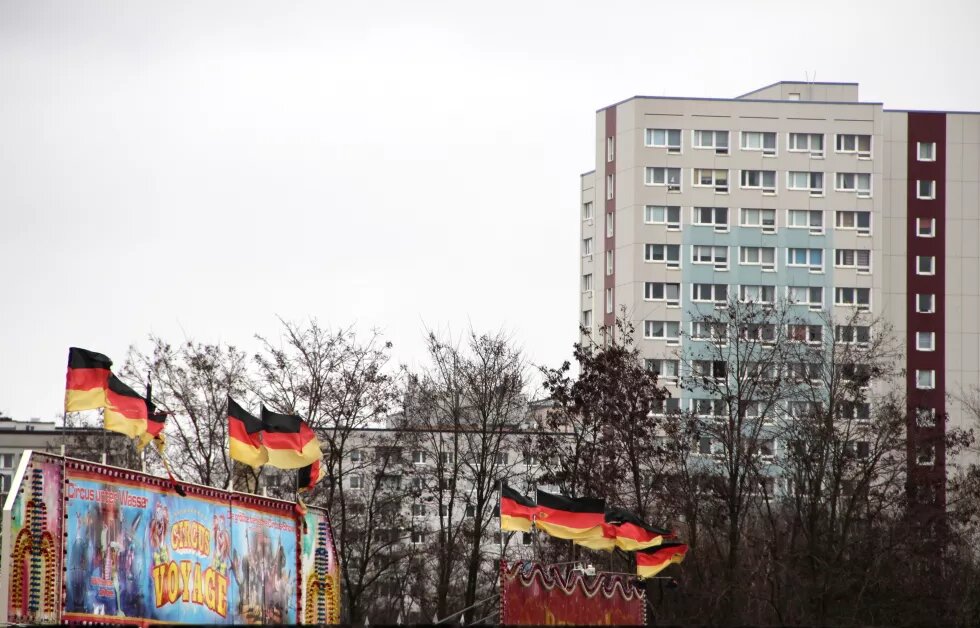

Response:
(580, 82), (980, 509)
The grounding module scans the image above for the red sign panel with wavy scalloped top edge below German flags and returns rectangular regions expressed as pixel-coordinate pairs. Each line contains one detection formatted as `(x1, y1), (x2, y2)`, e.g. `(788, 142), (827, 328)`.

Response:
(500, 562), (646, 626)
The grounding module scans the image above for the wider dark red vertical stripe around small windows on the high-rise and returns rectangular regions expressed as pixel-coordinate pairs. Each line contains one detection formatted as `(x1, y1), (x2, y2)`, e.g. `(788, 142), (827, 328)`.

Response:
(906, 112), (946, 523)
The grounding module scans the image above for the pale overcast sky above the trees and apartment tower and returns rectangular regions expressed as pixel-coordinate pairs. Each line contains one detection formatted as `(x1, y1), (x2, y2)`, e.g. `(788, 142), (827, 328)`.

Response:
(0, 0), (980, 419)
